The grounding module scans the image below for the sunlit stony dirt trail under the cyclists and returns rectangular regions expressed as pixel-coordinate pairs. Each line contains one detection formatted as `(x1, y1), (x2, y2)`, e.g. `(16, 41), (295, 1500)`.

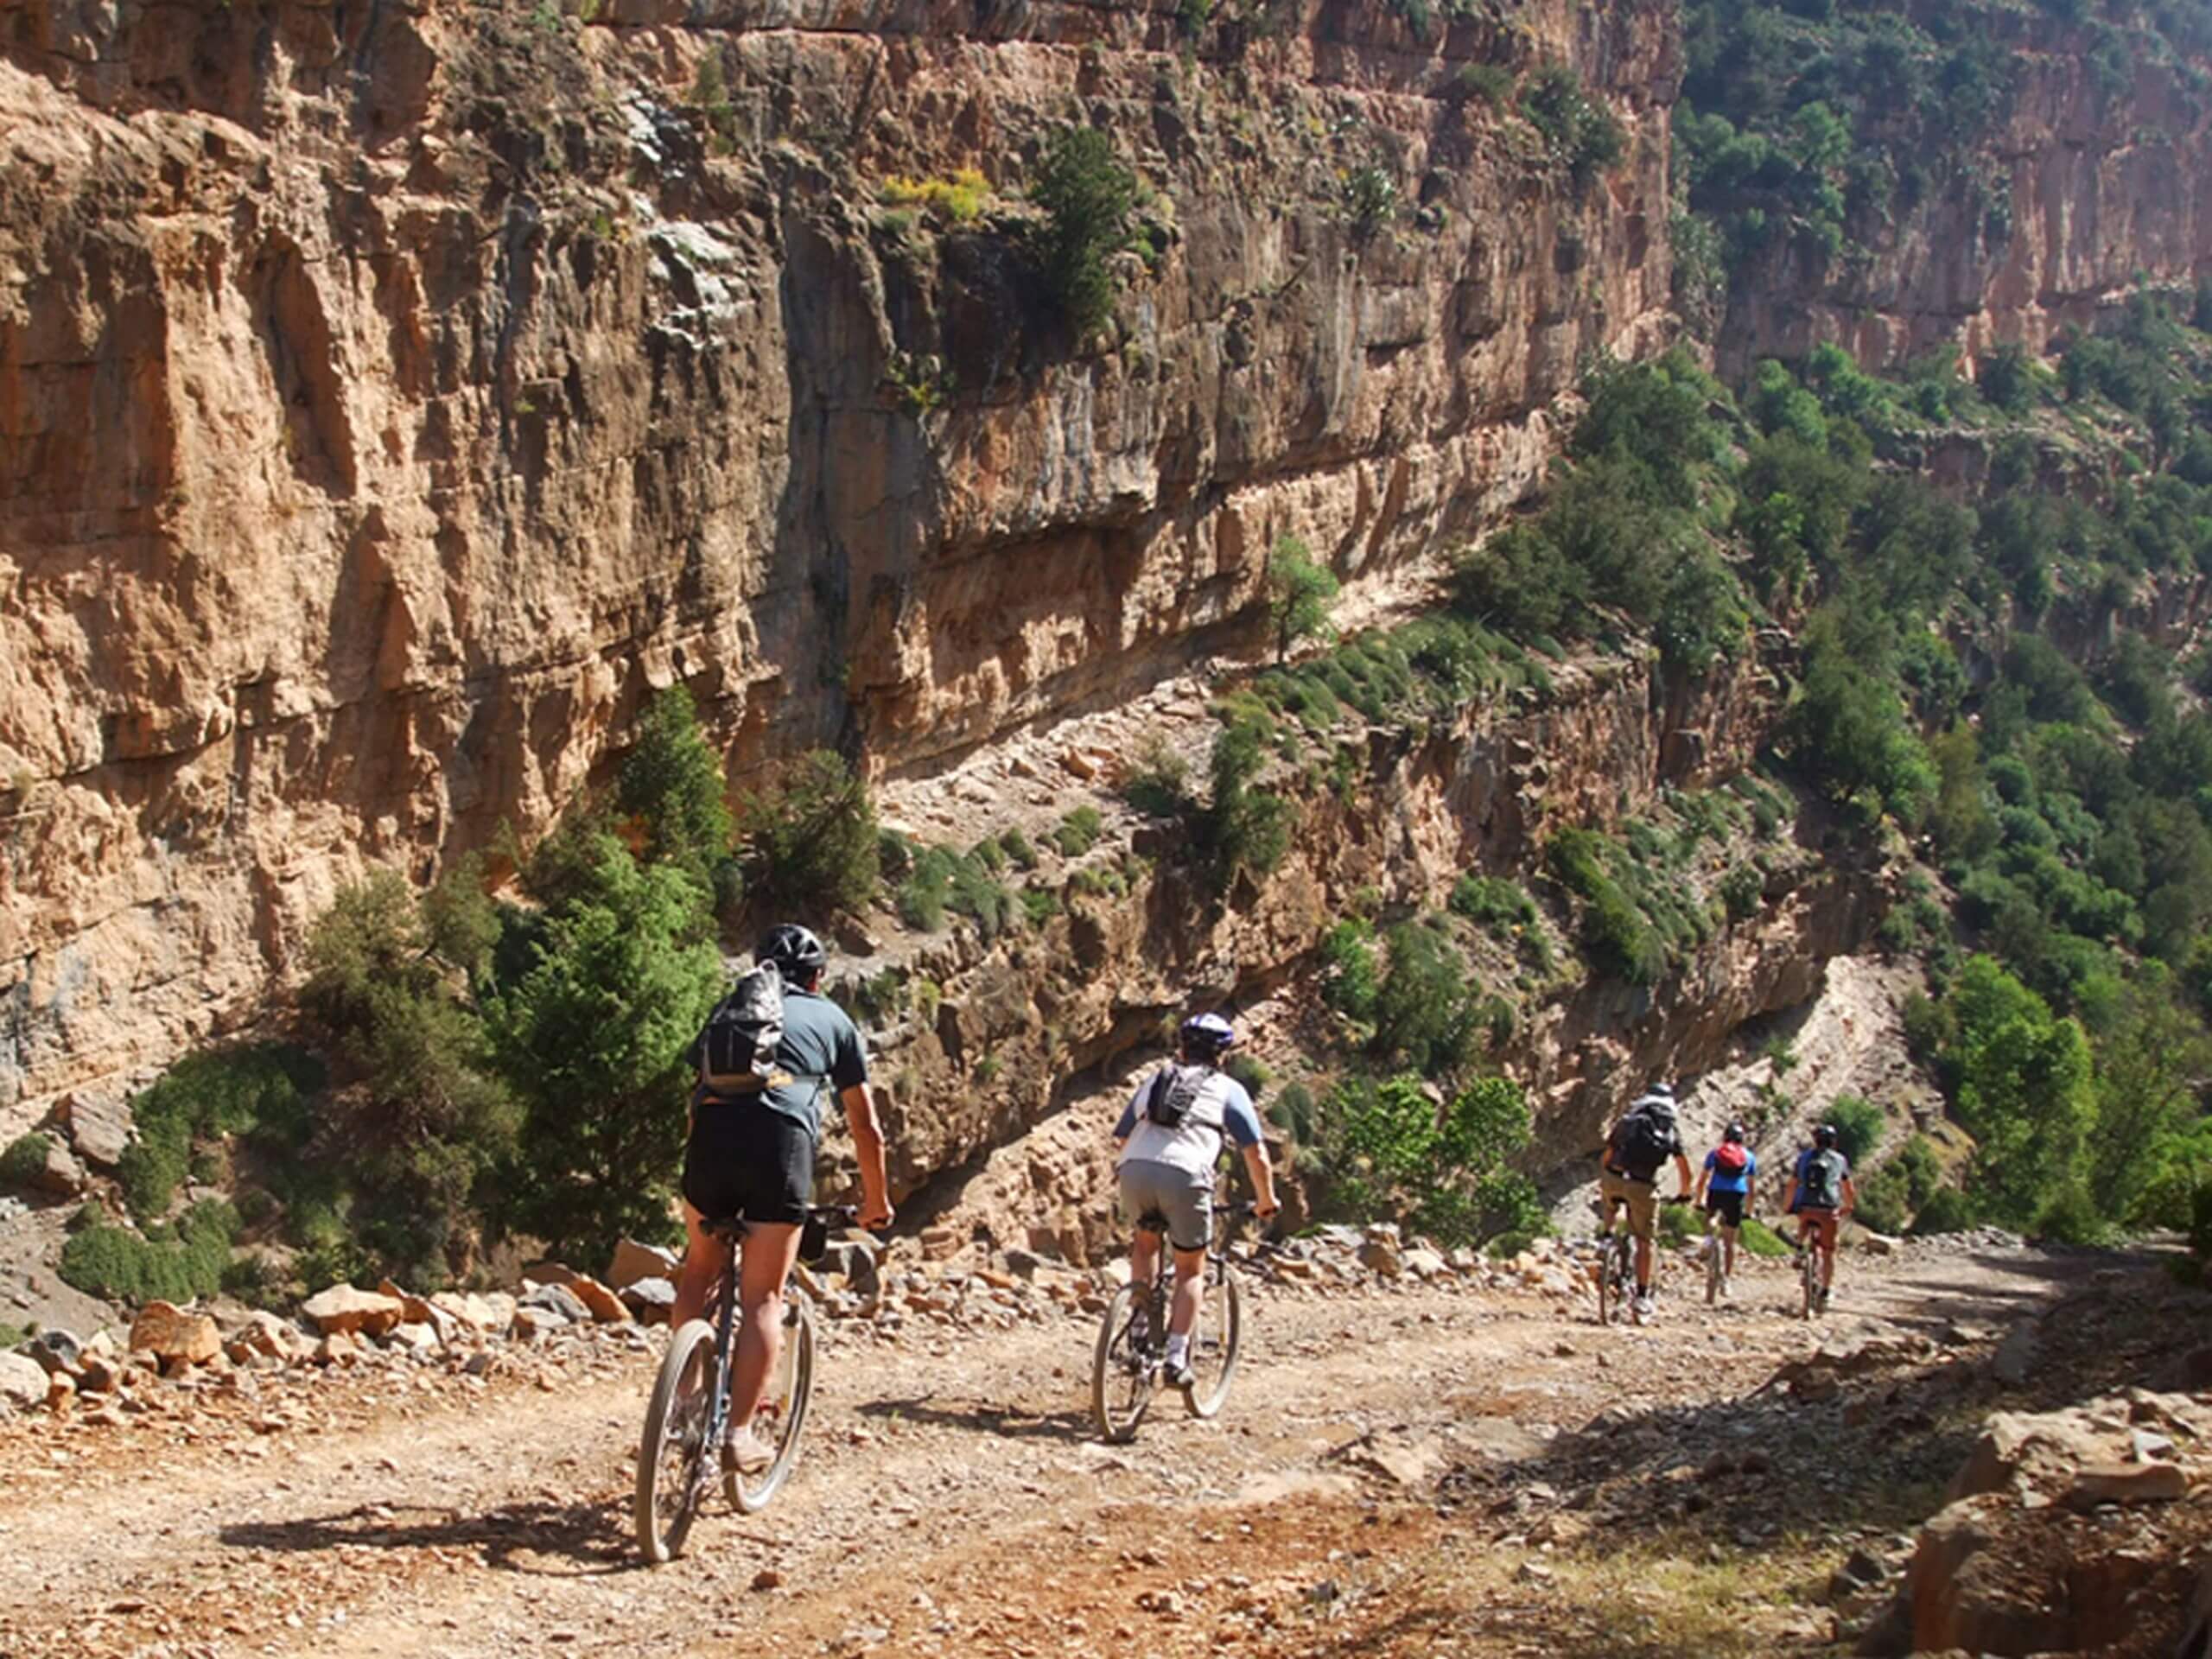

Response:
(0, 1252), (2123, 1659)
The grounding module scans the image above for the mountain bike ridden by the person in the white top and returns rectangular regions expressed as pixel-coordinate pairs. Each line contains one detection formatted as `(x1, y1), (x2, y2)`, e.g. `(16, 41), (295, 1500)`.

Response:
(1090, 1201), (1259, 1442)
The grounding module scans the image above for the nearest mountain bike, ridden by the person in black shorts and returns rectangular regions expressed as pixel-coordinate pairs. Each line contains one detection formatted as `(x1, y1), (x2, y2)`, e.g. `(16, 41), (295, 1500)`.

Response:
(632, 1205), (858, 1561)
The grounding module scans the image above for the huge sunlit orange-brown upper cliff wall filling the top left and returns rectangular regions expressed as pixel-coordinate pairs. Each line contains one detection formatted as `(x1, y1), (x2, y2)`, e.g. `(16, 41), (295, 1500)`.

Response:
(0, 0), (1676, 1128)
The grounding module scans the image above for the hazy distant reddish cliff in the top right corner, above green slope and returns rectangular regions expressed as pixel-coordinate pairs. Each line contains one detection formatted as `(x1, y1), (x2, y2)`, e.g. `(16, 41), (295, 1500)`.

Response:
(1717, 7), (2212, 372)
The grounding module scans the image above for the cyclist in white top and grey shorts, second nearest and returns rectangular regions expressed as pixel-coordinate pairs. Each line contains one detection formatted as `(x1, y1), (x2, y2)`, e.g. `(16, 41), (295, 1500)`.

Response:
(1113, 1013), (1276, 1389)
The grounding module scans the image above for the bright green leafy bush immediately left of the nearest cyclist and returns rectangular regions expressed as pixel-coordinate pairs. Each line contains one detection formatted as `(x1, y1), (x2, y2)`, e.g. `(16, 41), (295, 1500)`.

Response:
(489, 827), (721, 1261)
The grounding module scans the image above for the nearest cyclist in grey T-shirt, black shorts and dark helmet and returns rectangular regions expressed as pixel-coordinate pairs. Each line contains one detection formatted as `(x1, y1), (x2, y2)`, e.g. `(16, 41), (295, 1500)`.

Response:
(671, 923), (892, 1473)
